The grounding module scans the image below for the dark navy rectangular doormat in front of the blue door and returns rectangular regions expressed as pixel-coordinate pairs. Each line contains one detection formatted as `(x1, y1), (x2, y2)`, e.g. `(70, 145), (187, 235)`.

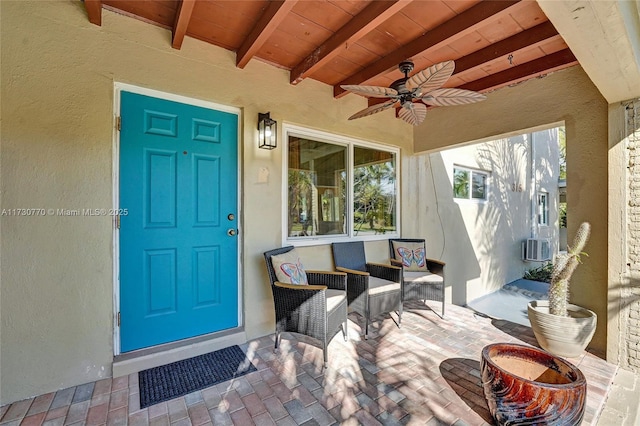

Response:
(138, 345), (256, 408)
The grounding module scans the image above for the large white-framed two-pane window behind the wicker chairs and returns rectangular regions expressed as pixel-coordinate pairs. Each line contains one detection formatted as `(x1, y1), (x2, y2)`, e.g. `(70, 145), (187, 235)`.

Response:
(285, 126), (398, 240)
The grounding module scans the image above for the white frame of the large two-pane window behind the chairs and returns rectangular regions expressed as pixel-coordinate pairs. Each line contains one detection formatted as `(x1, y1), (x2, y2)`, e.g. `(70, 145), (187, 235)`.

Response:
(281, 123), (401, 246)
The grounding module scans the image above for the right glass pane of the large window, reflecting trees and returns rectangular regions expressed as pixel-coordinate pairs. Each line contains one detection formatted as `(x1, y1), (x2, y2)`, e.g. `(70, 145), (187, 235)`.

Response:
(353, 146), (396, 235)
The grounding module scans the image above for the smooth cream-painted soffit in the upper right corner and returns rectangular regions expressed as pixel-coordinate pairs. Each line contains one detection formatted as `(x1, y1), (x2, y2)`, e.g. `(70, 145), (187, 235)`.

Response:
(537, 0), (640, 103)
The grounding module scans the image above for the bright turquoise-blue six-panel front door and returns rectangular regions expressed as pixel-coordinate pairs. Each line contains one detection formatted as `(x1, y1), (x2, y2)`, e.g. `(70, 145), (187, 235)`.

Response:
(120, 91), (238, 352)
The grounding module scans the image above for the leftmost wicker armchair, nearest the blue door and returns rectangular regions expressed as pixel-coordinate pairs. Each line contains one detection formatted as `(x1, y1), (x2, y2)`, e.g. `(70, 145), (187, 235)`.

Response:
(264, 246), (347, 366)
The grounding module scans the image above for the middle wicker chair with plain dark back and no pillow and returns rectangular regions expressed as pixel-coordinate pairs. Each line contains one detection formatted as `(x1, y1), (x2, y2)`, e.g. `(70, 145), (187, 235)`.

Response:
(331, 241), (402, 339)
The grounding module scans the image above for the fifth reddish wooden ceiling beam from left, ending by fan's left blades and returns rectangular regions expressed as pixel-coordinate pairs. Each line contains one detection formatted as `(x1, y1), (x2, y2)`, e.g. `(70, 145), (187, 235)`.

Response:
(333, 0), (521, 97)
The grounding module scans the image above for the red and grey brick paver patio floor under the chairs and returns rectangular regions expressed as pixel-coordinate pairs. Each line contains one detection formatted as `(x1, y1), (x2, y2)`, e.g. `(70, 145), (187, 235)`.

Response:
(0, 302), (616, 426)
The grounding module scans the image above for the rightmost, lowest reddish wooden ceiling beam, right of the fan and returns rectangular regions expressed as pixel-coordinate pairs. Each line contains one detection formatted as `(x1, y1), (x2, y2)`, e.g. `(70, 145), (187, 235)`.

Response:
(460, 49), (578, 92)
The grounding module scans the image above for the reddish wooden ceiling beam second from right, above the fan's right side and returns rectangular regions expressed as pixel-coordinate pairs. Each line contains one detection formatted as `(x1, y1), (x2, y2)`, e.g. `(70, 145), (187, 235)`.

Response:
(453, 21), (560, 75)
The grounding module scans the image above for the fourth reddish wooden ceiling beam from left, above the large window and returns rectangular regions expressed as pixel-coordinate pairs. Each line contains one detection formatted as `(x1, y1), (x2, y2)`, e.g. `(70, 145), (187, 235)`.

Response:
(290, 0), (412, 85)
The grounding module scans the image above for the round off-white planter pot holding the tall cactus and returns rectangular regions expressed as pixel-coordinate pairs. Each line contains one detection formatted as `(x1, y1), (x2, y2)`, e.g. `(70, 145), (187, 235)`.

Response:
(527, 300), (598, 358)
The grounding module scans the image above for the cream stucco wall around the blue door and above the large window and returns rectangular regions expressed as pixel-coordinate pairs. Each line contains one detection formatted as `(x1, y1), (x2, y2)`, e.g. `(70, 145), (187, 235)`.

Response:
(0, 0), (412, 405)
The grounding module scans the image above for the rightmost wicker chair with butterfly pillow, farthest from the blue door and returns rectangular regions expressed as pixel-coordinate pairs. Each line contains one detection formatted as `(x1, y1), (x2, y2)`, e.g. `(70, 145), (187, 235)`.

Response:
(389, 238), (445, 317)
